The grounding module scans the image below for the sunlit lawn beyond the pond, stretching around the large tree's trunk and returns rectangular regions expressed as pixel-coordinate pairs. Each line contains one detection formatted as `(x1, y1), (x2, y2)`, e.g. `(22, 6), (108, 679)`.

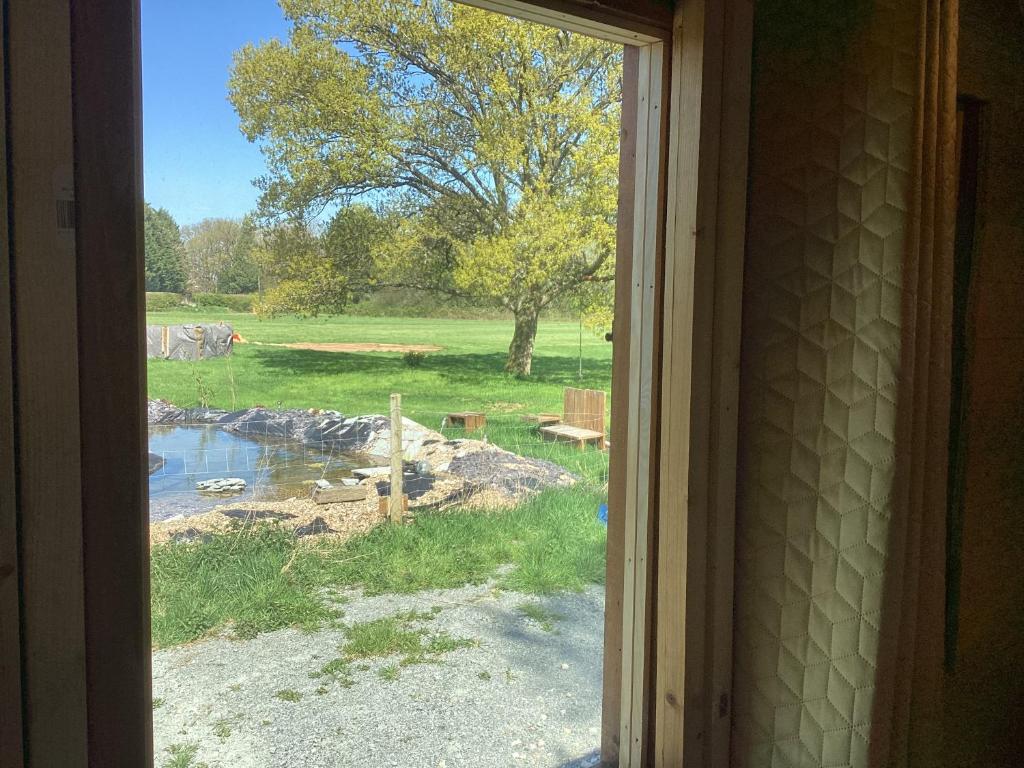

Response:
(147, 308), (611, 482)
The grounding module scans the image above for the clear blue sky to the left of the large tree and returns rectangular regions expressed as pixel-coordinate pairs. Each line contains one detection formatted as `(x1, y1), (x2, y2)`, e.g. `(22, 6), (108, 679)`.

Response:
(142, 0), (288, 224)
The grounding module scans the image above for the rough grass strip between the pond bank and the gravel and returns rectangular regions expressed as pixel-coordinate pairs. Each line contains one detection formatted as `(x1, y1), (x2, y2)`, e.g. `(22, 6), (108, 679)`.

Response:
(152, 487), (605, 652)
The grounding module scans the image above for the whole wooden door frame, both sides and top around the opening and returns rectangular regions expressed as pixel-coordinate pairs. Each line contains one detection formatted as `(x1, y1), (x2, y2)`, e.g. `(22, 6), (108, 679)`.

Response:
(0, 0), (753, 768)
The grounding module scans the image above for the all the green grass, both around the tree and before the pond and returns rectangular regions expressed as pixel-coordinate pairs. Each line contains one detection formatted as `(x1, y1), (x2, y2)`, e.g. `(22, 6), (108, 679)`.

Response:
(147, 309), (611, 647)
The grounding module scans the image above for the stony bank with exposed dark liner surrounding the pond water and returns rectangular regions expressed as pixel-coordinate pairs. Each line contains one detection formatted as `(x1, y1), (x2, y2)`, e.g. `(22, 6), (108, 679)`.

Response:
(148, 400), (579, 541)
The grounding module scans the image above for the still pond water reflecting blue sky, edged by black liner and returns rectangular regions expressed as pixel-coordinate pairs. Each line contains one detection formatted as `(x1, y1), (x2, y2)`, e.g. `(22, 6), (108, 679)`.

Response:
(150, 426), (374, 520)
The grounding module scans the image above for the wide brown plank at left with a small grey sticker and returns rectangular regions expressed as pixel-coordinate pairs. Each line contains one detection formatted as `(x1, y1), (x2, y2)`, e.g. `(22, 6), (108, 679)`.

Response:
(7, 0), (88, 768)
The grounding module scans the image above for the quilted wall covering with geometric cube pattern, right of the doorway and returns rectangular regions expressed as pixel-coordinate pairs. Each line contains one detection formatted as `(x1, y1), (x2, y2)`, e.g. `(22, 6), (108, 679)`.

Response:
(732, 0), (919, 768)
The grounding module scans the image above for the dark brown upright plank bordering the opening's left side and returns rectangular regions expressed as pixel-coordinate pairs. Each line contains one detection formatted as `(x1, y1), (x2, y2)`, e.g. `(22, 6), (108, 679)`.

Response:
(71, 0), (153, 768)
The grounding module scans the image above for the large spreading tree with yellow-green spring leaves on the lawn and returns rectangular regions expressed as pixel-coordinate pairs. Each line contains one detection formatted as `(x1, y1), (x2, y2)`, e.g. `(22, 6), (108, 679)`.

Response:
(230, 0), (622, 374)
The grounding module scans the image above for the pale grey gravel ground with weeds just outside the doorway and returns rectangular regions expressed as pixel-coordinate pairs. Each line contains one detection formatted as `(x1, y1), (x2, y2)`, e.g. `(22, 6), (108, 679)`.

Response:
(153, 584), (604, 768)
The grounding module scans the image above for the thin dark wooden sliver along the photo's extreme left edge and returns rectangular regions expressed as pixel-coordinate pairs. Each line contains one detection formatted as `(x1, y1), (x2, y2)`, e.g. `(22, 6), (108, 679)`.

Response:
(0, 0), (25, 768)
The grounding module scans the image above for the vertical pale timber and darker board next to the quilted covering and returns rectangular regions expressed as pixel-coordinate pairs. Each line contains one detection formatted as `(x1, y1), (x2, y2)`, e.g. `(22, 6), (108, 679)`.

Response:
(652, 0), (753, 768)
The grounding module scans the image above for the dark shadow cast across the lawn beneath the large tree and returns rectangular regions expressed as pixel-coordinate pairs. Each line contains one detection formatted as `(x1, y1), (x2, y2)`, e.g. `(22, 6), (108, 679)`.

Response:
(247, 347), (611, 388)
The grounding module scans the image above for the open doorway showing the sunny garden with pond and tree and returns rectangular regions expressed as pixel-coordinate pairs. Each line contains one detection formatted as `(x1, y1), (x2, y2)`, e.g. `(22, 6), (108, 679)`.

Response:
(142, 2), (662, 766)
